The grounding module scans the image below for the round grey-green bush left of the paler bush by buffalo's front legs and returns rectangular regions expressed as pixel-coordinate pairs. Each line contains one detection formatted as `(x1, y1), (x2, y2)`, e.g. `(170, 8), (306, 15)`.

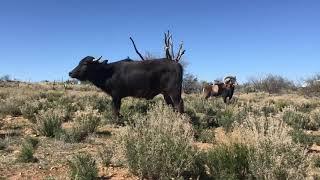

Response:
(36, 109), (63, 137)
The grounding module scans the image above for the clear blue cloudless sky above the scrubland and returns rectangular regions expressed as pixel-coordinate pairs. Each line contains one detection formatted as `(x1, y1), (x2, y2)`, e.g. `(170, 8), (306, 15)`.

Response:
(0, 0), (320, 81)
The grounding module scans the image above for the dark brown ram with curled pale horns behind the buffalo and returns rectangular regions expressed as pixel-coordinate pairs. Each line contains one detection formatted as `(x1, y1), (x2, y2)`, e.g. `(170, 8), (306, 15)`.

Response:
(203, 76), (237, 103)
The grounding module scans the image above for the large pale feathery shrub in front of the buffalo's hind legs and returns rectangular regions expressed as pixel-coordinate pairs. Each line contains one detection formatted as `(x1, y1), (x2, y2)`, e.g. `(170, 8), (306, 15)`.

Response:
(119, 103), (195, 179)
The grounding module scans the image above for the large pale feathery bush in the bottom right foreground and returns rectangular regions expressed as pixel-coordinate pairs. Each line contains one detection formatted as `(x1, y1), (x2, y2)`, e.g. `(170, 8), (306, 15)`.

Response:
(239, 115), (309, 179)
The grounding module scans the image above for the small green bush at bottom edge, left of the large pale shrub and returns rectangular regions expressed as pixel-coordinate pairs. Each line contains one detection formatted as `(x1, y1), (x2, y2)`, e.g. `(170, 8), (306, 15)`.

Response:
(68, 154), (98, 180)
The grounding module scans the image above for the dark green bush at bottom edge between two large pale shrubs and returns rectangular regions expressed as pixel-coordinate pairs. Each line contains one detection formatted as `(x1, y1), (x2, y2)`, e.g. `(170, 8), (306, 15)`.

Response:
(205, 144), (251, 179)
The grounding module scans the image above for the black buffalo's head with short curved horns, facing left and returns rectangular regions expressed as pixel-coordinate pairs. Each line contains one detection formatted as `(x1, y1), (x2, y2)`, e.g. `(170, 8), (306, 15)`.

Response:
(69, 56), (107, 81)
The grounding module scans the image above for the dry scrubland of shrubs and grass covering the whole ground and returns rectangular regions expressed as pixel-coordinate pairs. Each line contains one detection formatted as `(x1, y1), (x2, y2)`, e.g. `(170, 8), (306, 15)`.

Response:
(0, 74), (320, 179)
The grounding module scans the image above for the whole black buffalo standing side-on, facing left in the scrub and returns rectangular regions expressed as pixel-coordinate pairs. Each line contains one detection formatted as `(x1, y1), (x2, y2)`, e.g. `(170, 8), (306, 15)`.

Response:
(69, 56), (184, 117)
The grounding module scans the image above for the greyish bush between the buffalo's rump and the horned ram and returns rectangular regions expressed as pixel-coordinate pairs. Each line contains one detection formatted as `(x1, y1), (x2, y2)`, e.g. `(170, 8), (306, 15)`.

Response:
(182, 73), (202, 94)
